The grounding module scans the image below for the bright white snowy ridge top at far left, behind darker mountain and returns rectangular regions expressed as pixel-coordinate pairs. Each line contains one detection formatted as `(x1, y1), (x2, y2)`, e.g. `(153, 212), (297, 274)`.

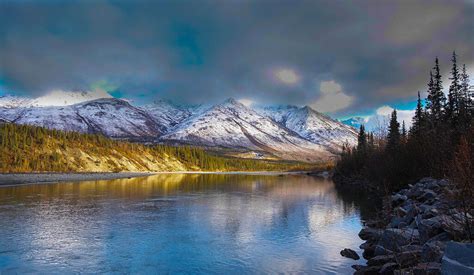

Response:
(0, 90), (112, 108)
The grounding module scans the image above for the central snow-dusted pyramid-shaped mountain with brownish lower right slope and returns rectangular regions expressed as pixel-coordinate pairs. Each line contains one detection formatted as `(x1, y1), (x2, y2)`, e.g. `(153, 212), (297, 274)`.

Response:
(161, 99), (332, 161)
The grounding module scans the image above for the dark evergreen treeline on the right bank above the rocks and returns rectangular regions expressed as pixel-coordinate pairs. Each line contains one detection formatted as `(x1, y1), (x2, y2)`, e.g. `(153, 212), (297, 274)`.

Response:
(335, 52), (474, 192)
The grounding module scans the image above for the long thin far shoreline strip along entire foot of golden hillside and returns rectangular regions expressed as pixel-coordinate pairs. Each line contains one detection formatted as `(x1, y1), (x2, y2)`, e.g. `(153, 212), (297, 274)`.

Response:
(0, 171), (316, 187)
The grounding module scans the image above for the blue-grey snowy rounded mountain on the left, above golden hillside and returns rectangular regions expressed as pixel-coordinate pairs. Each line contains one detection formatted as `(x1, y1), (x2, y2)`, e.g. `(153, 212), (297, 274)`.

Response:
(0, 98), (164, 138)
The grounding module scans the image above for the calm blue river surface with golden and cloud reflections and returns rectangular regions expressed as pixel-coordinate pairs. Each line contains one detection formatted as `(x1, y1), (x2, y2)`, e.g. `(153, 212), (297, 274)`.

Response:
(0, 174), (370, 274)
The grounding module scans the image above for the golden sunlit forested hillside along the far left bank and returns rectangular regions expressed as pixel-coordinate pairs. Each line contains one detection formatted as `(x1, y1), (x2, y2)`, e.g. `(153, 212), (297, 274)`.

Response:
(0, 123), (314, 172)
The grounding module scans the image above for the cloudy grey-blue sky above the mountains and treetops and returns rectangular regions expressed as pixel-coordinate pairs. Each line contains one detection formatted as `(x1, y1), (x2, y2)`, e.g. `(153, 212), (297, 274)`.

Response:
(0, 0), (474, 117)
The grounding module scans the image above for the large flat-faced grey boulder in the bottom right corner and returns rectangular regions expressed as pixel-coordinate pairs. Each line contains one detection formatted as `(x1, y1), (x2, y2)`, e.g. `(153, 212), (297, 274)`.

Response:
(441, 242), (474, 275)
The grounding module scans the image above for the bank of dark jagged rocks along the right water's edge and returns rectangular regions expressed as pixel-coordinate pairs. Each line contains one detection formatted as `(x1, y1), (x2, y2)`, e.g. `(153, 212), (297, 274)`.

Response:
(341, 178), (474, 274)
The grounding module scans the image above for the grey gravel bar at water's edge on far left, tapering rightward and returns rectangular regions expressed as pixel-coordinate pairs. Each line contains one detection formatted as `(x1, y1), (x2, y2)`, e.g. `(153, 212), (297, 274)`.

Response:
(0, 172), (154, 186)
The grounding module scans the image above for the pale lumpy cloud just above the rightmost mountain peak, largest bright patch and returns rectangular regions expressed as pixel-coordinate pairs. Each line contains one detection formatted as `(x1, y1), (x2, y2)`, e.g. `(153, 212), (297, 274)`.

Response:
(311, 80), (354, 112)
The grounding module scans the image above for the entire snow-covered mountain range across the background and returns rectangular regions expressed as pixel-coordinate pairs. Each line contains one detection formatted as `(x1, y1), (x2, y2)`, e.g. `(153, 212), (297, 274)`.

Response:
(0, 92), (357, 162)
